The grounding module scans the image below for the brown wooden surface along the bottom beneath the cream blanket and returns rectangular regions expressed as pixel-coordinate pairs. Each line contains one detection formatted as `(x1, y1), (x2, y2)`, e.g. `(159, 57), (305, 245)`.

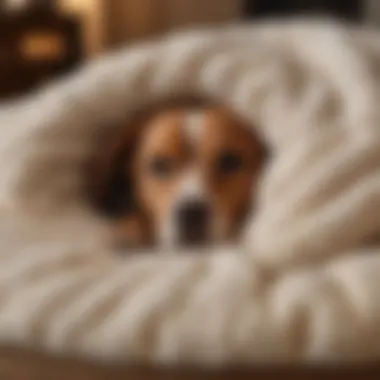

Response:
(0, 348), (380, 380)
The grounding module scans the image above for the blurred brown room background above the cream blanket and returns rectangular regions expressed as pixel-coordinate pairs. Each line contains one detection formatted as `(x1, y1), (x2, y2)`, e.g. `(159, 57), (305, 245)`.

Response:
(0, 0), (380, 100)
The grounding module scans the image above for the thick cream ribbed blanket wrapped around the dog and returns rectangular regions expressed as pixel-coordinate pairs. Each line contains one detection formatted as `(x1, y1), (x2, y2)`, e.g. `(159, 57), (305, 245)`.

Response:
(0, 20), (380, 378)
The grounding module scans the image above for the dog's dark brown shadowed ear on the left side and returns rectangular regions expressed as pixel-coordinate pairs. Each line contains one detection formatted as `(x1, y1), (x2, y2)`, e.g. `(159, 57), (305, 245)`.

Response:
(89, 111), (148, 218)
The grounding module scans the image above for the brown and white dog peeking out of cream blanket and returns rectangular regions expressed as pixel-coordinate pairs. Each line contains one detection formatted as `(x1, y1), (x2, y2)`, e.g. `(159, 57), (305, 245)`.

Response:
(92, 105), (266, 248)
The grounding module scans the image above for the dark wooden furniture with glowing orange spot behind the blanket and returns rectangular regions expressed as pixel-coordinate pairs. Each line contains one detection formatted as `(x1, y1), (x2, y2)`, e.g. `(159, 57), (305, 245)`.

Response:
(0, 9), (82, 100)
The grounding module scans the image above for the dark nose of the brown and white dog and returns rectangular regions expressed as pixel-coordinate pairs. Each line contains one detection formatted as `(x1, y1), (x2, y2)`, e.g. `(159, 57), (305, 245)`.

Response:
(177, 200), (210, 244)
